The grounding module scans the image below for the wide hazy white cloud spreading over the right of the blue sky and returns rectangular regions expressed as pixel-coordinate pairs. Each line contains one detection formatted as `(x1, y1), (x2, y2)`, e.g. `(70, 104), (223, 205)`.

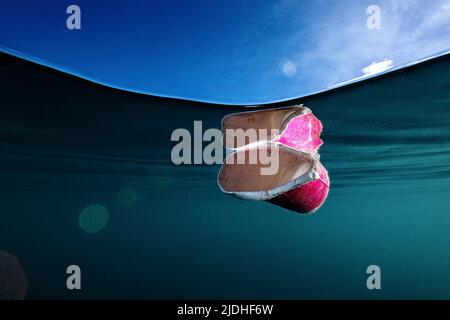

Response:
(278, 0), (450, 91)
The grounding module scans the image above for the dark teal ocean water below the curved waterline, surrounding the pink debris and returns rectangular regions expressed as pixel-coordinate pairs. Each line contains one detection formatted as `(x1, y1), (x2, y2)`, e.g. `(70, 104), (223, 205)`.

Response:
(0, 52), (450, 299)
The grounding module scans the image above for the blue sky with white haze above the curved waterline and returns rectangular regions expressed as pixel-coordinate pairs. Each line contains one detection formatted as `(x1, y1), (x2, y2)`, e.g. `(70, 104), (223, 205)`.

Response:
(0, 0), (450, 105)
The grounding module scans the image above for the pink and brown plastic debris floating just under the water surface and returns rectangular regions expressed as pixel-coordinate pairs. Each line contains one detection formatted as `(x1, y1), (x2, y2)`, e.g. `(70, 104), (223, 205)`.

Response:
(218, 105), (330, 213)
